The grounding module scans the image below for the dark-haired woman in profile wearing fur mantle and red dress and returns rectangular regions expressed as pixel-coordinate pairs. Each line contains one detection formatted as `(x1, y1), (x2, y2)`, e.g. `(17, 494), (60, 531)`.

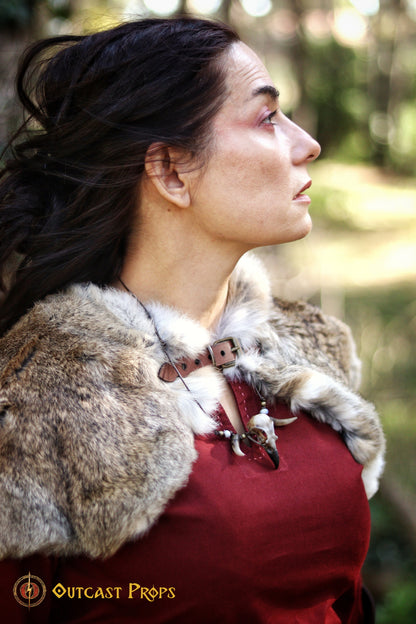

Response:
(0, 18), (384, 624)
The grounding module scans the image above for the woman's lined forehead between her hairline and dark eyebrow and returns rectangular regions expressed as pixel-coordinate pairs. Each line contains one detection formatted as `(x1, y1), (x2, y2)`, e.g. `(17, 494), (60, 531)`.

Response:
(221, 42), (273, 101)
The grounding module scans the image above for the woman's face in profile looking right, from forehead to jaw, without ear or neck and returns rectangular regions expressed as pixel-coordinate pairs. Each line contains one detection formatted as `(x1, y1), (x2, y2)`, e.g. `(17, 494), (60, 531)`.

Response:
(188, 43), (320, 253)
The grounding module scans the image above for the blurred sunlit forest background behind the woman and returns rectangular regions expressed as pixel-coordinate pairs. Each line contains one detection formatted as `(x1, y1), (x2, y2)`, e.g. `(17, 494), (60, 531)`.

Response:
(0, 0), (416, 624)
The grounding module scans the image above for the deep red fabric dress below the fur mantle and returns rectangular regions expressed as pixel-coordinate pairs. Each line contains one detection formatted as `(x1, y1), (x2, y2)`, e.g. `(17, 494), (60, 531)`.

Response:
(0, 383), (370, 624)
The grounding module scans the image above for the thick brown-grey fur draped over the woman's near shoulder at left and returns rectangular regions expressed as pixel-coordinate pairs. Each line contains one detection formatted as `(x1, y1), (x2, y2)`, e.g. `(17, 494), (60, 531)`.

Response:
(0, 287), (196, 558)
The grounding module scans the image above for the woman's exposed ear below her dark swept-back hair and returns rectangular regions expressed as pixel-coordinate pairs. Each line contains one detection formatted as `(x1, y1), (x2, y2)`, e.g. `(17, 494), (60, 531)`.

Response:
(145, 143), (191, 208)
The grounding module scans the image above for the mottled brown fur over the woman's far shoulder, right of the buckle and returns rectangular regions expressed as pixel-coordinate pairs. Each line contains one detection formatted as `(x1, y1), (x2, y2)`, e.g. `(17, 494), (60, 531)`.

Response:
(271, 297), (361, 389)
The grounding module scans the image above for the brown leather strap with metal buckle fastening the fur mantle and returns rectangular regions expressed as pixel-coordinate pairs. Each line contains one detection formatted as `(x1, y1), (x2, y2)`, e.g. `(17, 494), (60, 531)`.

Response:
(158, 338), (241, 382)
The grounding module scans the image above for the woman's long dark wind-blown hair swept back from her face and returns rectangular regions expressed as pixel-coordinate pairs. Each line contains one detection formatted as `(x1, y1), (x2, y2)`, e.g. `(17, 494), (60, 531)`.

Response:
(0, 17), (239, 333)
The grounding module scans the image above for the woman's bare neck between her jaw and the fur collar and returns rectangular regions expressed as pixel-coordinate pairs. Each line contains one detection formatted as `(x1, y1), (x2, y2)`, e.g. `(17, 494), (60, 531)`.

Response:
(114, 182), (252, 329)
